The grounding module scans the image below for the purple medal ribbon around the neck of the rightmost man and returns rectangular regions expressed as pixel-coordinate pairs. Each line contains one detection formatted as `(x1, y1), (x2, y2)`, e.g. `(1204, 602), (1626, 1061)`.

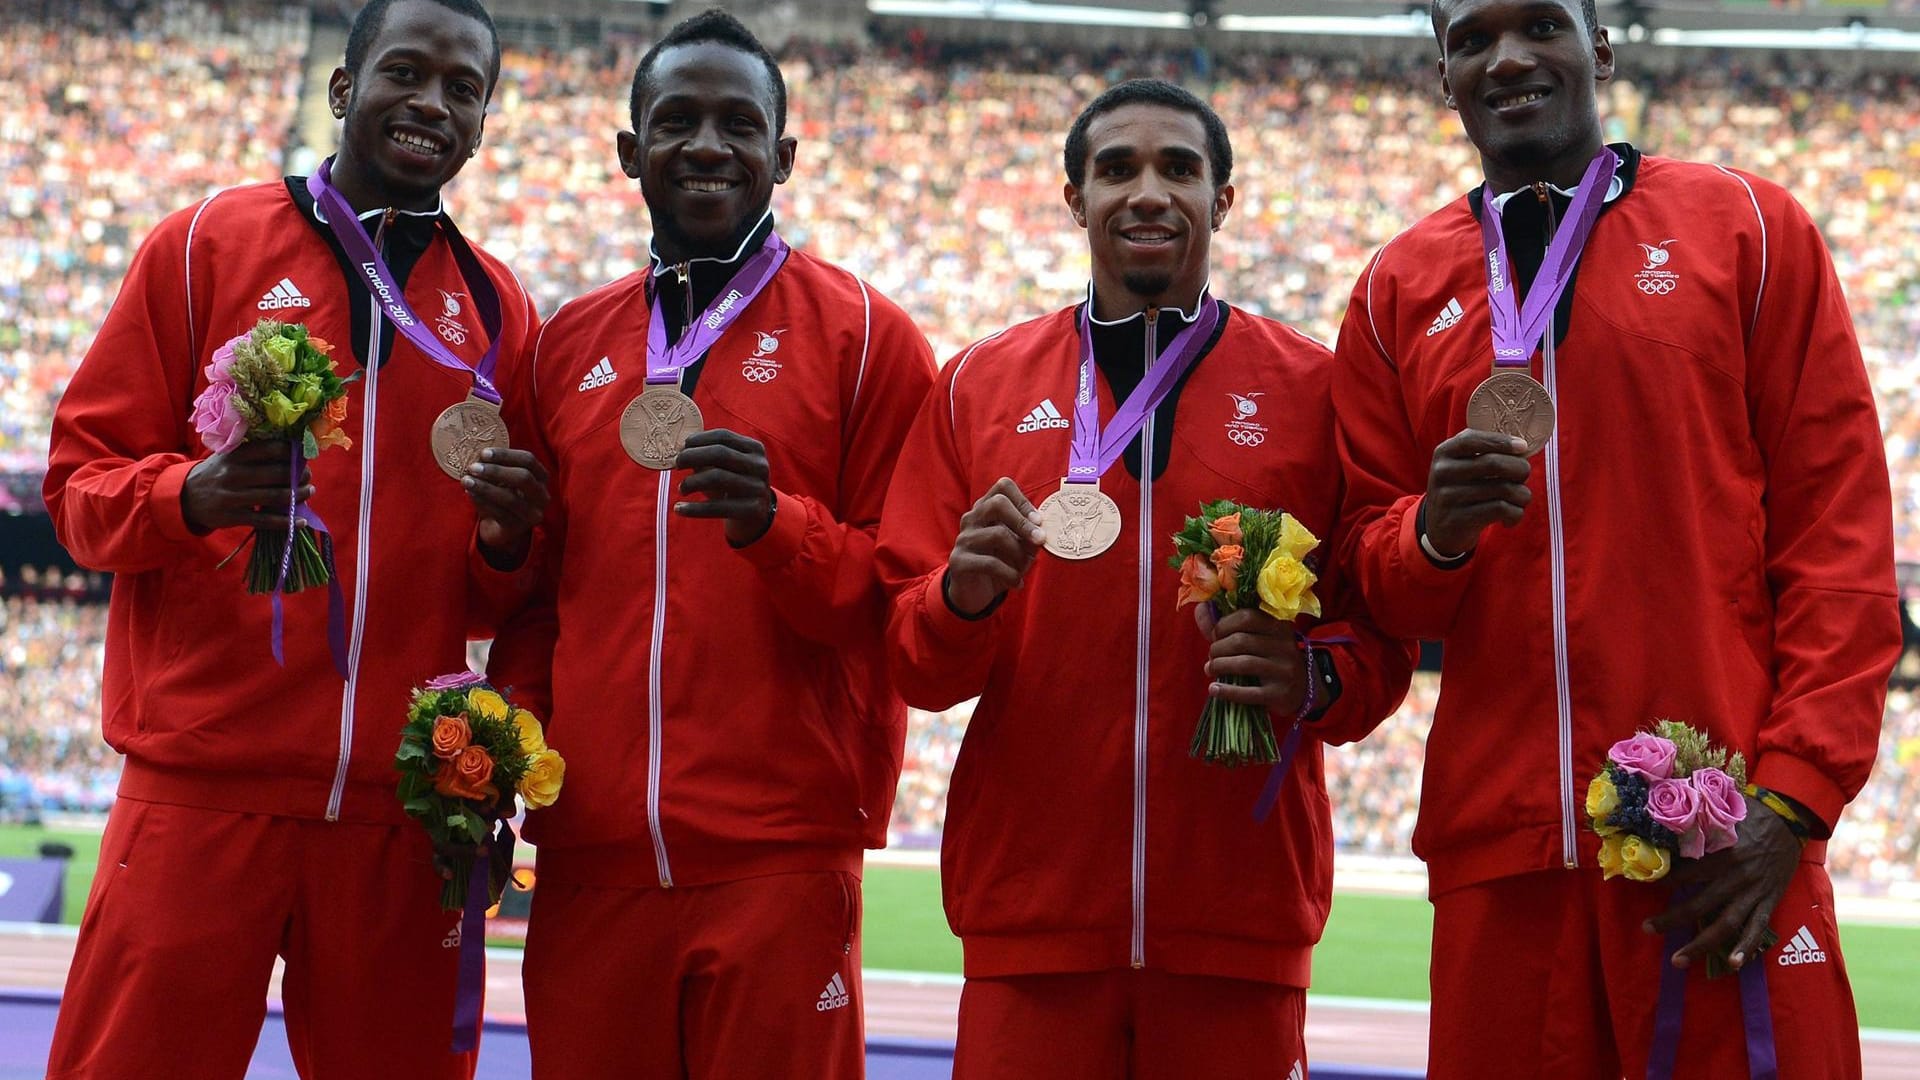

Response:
(1480, 146), (1620, 367)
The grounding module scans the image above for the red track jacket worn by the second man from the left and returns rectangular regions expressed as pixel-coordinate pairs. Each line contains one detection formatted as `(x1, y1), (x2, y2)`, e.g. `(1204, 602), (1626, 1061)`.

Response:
(490, 231), (933, 886)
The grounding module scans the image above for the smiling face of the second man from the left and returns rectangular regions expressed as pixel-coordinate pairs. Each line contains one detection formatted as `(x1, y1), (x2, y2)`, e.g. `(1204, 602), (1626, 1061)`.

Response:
(618, 42), (797, 261)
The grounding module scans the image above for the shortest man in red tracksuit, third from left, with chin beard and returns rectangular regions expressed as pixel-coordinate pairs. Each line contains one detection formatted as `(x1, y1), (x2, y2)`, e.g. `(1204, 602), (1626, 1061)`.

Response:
(881, 81), (1411, 1080)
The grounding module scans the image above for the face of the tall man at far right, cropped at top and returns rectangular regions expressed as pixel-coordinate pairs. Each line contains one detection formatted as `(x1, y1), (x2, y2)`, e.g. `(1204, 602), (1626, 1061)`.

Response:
(1434, 0), (1613, 190)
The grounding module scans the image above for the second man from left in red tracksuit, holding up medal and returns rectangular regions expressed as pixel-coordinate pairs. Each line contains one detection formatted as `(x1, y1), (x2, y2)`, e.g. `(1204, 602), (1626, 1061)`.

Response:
(492, 12), (933, 1080)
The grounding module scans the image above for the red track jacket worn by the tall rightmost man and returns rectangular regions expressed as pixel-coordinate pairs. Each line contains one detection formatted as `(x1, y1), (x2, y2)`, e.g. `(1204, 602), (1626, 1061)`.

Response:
(1334, 148), (1901, 894)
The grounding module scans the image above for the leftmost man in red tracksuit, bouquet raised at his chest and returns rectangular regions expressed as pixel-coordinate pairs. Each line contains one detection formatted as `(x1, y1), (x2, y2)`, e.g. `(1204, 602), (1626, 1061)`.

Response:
(46, 0), (545, 1080)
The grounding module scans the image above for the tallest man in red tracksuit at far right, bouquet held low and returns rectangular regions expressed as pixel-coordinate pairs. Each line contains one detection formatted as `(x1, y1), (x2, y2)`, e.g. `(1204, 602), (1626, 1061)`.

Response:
(1334, 0), (1901, 1078)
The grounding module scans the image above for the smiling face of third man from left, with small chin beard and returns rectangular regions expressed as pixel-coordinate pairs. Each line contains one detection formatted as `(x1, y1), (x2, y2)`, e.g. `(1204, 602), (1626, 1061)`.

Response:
(1066, 104), (1233, 319)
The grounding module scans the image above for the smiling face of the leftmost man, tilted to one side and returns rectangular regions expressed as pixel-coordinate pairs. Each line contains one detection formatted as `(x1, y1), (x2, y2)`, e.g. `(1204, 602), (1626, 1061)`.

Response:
(326, 0), (493, 211)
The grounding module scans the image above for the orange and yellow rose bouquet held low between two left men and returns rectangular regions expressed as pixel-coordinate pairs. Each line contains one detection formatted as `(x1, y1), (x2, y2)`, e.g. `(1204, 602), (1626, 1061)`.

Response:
(394, 671), (566, 911)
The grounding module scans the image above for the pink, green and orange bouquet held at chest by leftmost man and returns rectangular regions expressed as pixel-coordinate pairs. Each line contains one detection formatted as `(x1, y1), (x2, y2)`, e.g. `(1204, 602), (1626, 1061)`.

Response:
(192, 319), (359, 592)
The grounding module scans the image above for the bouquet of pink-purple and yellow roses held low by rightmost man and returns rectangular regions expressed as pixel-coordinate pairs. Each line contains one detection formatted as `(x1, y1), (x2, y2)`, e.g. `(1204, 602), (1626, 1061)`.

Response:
(1586, 721), (1747, 882)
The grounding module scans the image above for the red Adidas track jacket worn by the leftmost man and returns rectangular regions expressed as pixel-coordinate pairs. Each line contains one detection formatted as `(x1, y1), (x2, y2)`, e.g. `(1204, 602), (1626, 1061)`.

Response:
(46, 183), (538, 822)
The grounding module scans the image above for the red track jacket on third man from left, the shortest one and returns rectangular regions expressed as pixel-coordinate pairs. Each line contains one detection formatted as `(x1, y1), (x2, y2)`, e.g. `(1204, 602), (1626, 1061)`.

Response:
(881, 294), (1411, 986)
